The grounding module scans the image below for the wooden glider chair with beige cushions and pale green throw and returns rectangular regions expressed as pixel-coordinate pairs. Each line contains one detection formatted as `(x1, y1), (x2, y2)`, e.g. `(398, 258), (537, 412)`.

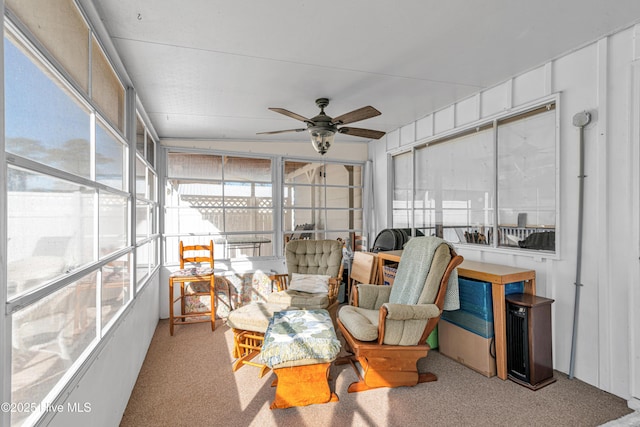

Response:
(337, 236), (463, 393)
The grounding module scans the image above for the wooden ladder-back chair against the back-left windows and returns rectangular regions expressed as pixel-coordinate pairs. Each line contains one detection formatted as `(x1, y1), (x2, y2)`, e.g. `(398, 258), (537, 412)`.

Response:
(169, 240), (216, 335)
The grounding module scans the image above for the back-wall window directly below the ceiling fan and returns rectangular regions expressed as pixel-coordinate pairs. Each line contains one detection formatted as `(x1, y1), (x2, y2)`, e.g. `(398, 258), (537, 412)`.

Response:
(283, 160), (363, 241)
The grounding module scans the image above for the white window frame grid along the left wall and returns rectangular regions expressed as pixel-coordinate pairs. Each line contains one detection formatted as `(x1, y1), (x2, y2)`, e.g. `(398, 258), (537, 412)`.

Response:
(0, 4), (160, 425)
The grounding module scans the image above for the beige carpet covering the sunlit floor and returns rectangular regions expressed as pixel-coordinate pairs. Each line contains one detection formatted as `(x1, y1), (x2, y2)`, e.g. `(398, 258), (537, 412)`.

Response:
(121, 320), (634, 427)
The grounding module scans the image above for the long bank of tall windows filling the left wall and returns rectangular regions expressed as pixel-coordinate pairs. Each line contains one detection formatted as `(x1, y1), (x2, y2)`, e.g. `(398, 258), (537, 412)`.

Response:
(0, 0), (158, 425)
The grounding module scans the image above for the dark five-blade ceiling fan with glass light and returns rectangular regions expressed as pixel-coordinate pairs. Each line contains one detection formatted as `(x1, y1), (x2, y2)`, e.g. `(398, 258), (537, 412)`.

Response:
(257, 98), (385, 154)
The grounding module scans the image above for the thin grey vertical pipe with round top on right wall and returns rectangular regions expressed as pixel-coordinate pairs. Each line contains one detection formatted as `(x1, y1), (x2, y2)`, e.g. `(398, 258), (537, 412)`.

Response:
(569, 111), (591, 379)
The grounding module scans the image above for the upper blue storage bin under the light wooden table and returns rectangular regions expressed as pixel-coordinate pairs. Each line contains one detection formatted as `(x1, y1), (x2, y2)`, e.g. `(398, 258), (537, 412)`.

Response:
(458, 277), (524, 320)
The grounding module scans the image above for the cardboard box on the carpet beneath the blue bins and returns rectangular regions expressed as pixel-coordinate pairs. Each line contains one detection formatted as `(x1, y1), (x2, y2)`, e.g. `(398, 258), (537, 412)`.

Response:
(438, 319), (496, 377)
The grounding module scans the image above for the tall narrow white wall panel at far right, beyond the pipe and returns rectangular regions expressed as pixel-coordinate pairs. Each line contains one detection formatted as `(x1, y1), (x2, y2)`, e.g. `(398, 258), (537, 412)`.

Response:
(594, 30), (640, 395)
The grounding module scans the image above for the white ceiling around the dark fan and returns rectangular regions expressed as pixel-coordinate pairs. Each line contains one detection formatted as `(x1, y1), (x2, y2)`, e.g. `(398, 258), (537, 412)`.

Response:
(93, 0), (640, 147)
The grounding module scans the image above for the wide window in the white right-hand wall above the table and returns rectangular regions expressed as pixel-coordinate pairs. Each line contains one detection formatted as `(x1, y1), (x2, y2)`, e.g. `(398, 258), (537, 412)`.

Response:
(392, 102), (557, 251)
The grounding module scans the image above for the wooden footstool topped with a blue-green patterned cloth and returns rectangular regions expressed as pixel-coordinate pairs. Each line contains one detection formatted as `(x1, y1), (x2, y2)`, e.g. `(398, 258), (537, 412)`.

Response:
(260, 309), (340, 409)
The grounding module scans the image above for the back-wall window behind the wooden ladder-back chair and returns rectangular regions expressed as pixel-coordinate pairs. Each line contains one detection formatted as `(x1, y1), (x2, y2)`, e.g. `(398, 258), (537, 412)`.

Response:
(164, 152), (274, 261)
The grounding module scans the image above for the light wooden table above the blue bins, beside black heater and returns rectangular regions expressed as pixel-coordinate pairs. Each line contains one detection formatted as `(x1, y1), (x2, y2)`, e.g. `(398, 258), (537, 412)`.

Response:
(458, 260), (536, 380)
